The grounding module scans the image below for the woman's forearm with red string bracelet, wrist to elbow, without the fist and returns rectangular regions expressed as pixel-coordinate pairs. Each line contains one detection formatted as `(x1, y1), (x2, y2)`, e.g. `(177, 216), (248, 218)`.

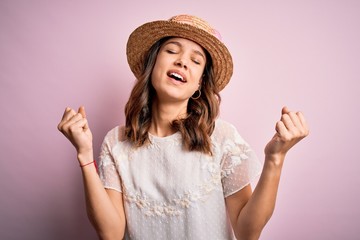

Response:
(78, 154), (125, 239)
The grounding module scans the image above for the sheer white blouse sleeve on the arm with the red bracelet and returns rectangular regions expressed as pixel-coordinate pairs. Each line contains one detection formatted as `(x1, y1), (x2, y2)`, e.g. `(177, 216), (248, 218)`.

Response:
(98, 127), (122, 192)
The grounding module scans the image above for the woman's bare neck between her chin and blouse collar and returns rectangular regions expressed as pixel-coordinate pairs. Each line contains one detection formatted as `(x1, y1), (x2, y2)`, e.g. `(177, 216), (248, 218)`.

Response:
(149, 100), (187, 137)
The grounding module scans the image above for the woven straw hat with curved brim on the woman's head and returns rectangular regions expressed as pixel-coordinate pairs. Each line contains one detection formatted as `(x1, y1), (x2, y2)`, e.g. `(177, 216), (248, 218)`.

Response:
(126, 15), (233, 91)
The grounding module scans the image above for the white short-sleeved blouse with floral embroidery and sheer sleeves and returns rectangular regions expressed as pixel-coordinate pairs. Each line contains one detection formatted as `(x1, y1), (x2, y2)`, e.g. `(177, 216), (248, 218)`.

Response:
(99, 119), (261, 240)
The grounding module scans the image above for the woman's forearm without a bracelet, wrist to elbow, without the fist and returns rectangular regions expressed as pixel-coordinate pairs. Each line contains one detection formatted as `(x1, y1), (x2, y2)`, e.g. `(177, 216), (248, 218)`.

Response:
(236, 156), (285, 239)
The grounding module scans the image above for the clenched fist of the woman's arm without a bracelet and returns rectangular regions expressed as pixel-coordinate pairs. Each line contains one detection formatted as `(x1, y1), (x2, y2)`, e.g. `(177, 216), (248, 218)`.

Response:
(265, 107), (309, 159)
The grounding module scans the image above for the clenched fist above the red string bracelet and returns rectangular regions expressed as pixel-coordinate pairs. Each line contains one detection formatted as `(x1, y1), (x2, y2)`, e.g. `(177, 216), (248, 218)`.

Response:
(58, 107), (93, 158)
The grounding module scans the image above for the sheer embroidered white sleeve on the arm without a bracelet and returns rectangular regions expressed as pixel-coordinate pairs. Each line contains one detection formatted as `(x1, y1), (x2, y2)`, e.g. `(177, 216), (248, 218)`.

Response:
(221, 121), (262, 197)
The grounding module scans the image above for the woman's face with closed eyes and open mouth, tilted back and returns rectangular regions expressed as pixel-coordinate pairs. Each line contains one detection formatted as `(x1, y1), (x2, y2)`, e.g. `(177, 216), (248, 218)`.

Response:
(151, 38), (206, 101)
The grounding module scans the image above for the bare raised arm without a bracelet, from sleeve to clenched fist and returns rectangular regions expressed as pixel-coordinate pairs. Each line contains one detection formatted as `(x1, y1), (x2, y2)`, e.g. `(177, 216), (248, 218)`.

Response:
(226, 107), (309, 240)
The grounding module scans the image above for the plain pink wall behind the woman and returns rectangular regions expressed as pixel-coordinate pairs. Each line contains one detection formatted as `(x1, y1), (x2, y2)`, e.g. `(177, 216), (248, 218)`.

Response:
(0, 0), (360, 240)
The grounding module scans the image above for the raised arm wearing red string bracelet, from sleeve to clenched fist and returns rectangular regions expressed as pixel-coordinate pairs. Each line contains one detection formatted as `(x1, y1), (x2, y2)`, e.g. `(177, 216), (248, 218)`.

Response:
(58, 107), (126, 239)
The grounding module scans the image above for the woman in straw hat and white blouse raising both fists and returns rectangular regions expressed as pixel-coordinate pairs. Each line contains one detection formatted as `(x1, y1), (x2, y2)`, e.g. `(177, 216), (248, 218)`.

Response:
(58, 15), (308, 239)
